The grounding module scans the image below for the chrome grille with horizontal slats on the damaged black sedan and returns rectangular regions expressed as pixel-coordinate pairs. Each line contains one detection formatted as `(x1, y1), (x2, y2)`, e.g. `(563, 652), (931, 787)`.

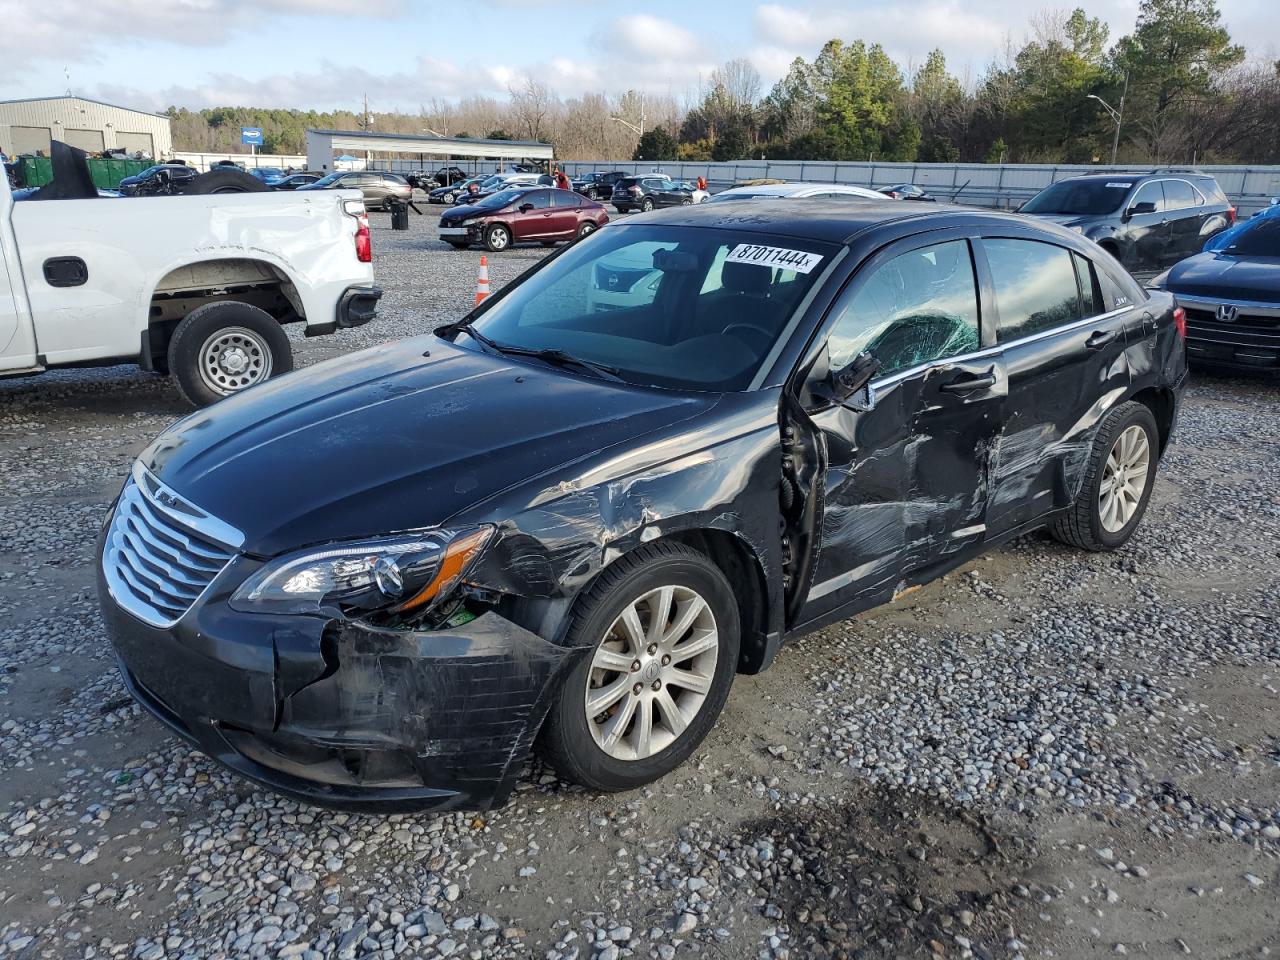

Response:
(102, 465), (244, 627)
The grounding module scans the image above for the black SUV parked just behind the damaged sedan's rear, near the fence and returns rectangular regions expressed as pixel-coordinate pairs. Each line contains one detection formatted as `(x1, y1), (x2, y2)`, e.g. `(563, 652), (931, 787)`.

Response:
(1021, 170), (1235, 271)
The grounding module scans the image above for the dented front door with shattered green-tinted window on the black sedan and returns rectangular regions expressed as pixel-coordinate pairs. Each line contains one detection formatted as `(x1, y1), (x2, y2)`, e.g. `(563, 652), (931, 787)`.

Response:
(795, 234), (1009, 627)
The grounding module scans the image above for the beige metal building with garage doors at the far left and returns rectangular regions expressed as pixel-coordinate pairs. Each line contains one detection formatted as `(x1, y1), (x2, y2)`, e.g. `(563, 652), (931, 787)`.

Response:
(0, 96), (173, 159)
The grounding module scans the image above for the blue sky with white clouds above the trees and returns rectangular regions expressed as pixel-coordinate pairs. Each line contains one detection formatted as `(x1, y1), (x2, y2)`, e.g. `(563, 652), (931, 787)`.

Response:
(0, 0), (1280, 110)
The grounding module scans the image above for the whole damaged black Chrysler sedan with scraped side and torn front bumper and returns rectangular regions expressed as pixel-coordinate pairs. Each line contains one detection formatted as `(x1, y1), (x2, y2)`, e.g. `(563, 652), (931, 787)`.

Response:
(101, 200), (1185, 809)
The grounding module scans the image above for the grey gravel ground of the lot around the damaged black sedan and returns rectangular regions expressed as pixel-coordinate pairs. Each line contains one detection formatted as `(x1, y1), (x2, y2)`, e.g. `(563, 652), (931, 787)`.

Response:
(0, 214), (1280, 960)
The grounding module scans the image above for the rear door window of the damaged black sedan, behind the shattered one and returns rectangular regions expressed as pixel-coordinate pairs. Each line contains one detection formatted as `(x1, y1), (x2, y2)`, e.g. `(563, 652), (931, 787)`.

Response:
(982, 239), (1082, 343)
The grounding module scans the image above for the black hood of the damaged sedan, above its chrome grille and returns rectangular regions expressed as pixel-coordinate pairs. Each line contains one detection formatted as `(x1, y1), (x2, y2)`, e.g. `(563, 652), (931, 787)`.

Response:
(142, 335), (716, 556)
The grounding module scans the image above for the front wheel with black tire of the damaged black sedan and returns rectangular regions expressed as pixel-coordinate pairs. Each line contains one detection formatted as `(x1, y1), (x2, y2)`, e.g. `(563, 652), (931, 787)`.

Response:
(539, 543), (741, 791)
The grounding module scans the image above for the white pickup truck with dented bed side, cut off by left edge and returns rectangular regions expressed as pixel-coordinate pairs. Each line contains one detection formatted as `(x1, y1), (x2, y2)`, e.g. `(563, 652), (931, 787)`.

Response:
(0, 146), (381, 406)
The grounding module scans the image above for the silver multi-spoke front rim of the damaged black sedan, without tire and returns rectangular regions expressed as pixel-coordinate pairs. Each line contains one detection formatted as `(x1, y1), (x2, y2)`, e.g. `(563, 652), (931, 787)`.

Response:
(585, 585), (719, 760)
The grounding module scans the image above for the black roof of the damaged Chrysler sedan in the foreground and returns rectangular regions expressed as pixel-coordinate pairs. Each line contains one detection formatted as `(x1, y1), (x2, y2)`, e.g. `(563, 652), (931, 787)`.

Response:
(629, 197), (1076, 243)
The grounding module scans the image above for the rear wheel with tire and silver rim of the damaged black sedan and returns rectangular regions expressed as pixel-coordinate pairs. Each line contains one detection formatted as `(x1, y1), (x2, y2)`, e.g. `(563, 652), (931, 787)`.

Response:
(1050, 401), (1160, 550)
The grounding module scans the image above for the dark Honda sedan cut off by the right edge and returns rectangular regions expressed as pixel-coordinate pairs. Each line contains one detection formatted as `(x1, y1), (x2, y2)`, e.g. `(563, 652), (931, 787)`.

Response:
(1151, 216), (1280, 374)
